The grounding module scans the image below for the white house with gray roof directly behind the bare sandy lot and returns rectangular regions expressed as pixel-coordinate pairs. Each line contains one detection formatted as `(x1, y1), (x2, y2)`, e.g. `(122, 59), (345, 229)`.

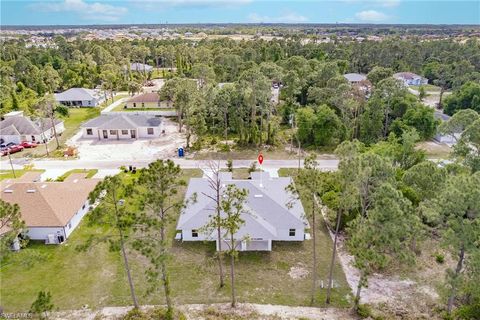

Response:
(82, 112), (163, 140)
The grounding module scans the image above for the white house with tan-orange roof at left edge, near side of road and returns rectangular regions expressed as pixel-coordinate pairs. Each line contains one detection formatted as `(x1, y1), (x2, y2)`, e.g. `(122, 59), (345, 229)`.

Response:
(2, 176), (99, 244)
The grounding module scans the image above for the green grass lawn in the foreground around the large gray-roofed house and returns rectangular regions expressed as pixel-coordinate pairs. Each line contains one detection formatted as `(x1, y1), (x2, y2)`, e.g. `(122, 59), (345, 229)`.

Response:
(0, 169), (350, 312)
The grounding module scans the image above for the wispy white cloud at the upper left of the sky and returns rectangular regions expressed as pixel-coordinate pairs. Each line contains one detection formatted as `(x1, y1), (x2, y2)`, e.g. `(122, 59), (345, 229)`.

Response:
(32, 0), (128, 22)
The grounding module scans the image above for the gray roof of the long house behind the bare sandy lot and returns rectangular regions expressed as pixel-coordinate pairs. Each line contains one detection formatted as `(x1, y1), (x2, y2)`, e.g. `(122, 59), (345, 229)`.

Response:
(82, 114), (162, 130)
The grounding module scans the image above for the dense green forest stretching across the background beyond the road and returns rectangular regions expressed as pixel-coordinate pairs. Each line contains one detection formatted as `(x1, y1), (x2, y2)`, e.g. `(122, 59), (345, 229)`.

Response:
(0, 36), (480, 148)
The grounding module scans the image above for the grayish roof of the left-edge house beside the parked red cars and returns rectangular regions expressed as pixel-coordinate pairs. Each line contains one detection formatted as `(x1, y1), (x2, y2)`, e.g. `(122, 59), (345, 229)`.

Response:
(0, 116), (62, 135)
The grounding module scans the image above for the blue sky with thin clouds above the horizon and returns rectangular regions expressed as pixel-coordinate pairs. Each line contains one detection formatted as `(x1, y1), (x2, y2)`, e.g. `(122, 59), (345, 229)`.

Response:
(0, 0), (480, 25)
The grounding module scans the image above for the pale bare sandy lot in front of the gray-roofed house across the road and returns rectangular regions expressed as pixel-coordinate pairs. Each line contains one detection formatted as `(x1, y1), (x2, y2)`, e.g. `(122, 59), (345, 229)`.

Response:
(67, 119), (185, 161)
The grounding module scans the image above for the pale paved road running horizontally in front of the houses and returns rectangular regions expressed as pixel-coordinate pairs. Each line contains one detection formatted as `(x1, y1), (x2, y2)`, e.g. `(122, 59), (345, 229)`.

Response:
(0, 158), (338, 170)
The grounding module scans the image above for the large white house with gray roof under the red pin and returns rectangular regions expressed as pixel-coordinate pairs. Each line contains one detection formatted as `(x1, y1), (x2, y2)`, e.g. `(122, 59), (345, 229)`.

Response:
(176, 172), (309, 251)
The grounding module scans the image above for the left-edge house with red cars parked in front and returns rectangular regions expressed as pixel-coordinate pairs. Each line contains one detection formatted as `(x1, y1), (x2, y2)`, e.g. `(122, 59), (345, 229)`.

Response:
(0, 111), (65, 144)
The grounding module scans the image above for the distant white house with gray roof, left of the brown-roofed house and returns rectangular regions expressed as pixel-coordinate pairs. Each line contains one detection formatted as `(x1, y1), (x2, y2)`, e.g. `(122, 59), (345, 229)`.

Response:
(55, 88), (105, 107)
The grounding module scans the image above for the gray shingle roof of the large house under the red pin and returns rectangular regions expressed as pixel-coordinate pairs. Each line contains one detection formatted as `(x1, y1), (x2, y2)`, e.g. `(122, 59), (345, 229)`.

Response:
(177, 175), (308, 239)
